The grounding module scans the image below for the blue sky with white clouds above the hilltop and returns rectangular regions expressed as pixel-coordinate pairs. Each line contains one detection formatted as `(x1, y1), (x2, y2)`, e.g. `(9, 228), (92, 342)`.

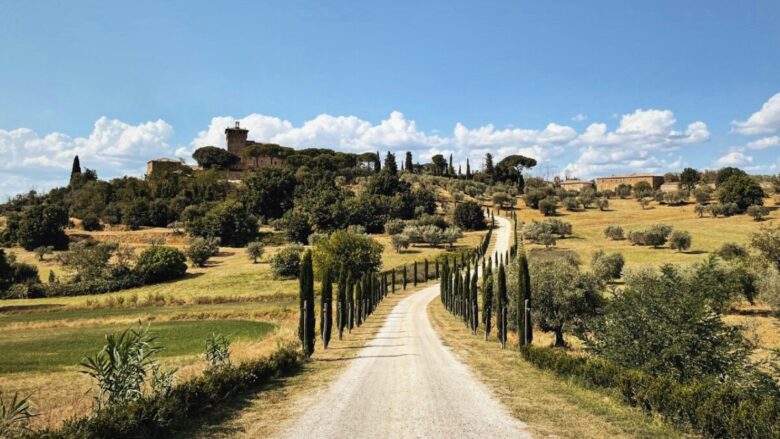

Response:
(0, 0), (780, 198)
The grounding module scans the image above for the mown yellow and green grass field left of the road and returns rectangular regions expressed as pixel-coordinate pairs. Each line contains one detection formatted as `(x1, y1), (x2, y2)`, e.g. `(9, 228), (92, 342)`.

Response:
(0, 229), (482, 426)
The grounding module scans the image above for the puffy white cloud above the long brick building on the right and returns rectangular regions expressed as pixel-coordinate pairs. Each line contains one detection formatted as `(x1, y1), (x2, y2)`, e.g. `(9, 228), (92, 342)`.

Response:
(565, 109), (710, 178)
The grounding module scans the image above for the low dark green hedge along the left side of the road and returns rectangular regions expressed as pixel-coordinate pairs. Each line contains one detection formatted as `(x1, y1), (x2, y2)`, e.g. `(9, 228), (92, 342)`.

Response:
(34, 346), (303, 439)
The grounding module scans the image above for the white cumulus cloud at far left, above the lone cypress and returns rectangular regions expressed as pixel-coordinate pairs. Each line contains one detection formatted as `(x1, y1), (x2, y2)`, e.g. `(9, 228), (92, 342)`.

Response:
(0, 117), (173, 196)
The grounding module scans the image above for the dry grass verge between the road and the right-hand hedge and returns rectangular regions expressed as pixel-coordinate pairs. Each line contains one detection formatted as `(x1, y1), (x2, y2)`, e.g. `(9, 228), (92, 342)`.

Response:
(428, 300), (683, 439)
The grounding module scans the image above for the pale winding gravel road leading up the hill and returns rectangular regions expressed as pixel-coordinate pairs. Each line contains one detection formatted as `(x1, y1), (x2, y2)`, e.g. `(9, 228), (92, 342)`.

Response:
(282, 217), (531, 439)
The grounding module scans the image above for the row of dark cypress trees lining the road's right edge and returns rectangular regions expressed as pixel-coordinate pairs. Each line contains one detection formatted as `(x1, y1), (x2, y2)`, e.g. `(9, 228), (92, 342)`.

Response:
(440, 214), (533, 348)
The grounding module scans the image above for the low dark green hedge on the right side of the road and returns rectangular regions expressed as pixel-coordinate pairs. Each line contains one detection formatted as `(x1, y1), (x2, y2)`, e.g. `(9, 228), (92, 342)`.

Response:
(520, 345), (780, 439)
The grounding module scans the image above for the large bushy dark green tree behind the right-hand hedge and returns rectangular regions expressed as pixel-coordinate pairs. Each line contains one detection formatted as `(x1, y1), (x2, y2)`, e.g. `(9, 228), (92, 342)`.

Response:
(588, 265), (749, 382)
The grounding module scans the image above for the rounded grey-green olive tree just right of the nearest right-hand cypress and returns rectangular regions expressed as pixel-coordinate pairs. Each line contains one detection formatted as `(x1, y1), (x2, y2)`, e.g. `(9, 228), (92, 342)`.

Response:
(531, 258), (602, 347)
